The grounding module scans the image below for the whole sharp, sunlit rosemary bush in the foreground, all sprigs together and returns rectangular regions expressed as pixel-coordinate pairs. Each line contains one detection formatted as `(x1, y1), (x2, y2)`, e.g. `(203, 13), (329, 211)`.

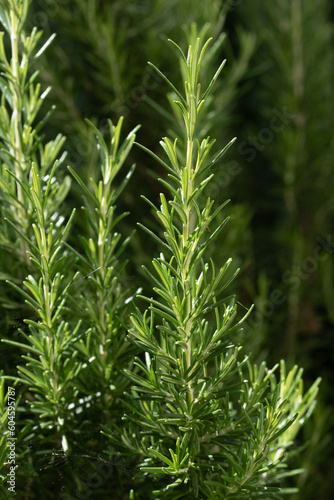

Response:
(0, 0), (319, 500)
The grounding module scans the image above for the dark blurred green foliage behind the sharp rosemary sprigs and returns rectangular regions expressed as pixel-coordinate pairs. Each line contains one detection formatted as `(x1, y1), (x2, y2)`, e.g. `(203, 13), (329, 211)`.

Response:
(0, 0), (334, 500)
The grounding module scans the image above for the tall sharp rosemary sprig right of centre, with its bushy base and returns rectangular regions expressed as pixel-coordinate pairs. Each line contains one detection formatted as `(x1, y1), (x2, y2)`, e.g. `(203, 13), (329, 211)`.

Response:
(103, 26), (319, 499)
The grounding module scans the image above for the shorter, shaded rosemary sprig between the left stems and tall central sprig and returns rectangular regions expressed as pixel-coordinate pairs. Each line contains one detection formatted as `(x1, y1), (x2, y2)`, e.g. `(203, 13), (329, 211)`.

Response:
(69, 118), (138, 412)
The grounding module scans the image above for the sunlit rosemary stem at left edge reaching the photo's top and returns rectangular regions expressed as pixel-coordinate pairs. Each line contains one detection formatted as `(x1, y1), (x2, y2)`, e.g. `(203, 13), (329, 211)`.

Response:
(0, 0), (64, 271)
